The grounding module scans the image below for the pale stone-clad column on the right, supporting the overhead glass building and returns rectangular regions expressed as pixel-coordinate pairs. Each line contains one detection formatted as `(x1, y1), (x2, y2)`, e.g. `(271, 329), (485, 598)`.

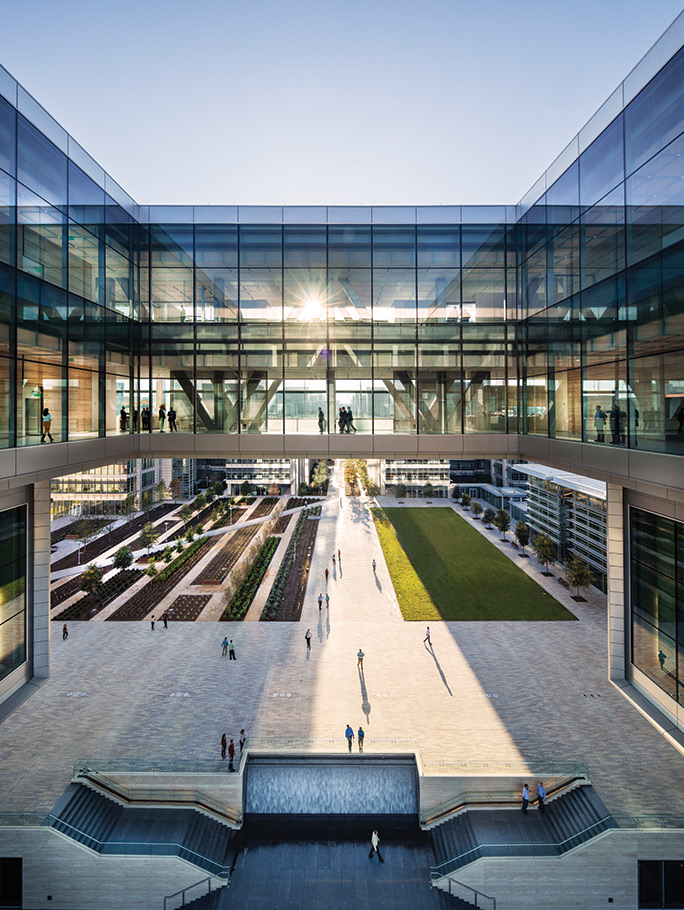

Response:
(606, 483), (626, 682)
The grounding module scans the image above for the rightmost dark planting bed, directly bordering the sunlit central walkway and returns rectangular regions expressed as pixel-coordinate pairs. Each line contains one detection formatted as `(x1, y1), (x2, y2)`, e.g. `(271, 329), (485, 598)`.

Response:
(261, 506), (321, 622)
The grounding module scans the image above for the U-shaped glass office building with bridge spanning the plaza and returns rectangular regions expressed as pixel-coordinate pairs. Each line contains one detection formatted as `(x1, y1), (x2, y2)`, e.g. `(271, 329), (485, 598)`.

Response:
(0, 17), (684, 722)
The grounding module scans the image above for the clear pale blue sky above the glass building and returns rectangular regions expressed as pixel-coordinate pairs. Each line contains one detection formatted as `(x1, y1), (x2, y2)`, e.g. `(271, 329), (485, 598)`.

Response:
(0, 0), (682, 205)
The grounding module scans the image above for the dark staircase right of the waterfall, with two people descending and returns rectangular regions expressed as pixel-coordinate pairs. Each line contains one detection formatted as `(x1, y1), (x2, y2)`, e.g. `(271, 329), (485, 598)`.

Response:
(431, 786), (617, 887)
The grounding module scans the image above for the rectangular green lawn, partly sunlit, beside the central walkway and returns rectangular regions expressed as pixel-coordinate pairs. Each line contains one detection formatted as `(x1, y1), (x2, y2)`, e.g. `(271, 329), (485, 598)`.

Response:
(373, 508), (576, 622)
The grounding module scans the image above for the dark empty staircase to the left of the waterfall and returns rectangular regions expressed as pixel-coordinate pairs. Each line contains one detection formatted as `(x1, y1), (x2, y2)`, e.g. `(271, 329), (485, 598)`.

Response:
(44, 784), (234, 875)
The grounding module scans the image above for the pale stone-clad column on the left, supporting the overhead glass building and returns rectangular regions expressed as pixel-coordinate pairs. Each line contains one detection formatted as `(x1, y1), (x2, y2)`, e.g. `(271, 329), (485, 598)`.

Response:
(29, 480), (50, 678)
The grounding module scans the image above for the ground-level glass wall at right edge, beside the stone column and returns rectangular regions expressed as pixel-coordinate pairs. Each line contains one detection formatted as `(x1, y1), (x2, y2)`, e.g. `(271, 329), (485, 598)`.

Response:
(630, 508), (684, 702)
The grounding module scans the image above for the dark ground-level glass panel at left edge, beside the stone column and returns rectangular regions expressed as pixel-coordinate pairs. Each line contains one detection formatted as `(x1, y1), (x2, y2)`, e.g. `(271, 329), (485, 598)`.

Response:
(0, 506), (27, 680)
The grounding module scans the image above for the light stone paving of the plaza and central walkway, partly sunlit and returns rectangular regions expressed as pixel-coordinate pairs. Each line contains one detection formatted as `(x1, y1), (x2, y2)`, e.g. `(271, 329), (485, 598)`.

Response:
(0, 470), (684, 828)
